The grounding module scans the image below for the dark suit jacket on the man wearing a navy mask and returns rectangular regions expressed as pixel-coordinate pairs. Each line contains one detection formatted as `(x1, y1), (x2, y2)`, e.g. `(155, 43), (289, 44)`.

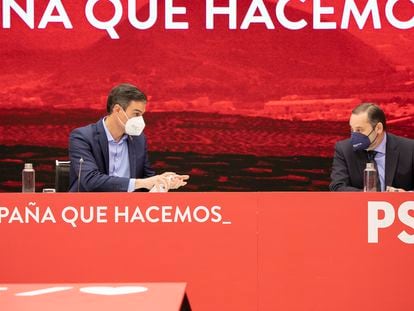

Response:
(329, 133), (414, 191)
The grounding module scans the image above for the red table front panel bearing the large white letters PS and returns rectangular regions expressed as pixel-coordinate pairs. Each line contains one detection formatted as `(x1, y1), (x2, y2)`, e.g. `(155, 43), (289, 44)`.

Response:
(258, 193), (414, 311)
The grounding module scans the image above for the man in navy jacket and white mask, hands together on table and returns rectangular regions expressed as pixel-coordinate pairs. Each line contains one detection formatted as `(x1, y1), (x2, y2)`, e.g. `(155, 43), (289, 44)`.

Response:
(69, 84), (189, 192)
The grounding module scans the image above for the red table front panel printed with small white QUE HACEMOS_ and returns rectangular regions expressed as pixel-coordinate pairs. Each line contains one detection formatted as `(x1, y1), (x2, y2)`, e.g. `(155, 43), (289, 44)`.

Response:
(0, 193), (257, 311)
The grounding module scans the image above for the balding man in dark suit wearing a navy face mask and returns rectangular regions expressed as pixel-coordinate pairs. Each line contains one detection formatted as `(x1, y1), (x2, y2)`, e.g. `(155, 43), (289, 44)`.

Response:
(329, 104), (414, 192)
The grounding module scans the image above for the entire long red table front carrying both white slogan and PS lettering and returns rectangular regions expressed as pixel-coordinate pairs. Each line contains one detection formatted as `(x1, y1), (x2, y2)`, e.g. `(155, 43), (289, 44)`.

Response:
(0, 193), (414, 311)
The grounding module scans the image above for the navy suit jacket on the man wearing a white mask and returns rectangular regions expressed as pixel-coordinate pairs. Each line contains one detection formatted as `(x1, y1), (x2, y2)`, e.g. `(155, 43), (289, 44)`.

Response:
(69, 119), (155, 192)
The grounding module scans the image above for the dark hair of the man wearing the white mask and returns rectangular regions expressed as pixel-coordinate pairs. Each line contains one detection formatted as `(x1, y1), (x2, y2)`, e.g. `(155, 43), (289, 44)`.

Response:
(106, 83), (147, 113)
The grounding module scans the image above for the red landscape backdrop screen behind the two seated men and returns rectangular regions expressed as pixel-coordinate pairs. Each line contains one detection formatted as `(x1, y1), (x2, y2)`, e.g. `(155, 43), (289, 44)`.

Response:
(0, 0), (414, 191)
